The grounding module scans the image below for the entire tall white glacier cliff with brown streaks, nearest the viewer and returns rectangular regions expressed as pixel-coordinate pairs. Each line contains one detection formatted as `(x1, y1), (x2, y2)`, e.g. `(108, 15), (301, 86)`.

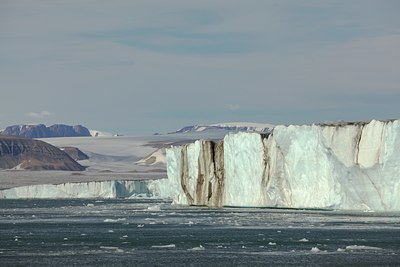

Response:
(163, 120), (400, 211)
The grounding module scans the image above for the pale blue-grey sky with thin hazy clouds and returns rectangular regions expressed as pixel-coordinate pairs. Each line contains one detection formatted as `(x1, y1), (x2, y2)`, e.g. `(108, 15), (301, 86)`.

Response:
(0, 0), (400, 135)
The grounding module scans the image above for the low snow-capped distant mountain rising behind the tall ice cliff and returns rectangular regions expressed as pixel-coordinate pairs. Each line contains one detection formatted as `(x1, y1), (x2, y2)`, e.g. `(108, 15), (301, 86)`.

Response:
(173, 122), (274, 133)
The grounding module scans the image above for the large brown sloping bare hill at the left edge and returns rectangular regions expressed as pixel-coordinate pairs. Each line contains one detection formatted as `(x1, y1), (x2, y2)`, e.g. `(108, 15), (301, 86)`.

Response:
(0, 135), (85, 171)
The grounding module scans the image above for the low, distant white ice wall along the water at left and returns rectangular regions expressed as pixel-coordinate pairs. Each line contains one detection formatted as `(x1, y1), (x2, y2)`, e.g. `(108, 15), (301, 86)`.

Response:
(0, 181), (152, 199)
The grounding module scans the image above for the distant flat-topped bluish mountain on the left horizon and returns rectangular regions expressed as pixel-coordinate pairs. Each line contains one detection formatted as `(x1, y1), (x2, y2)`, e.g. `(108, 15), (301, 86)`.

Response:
(0, 124), (91, 138)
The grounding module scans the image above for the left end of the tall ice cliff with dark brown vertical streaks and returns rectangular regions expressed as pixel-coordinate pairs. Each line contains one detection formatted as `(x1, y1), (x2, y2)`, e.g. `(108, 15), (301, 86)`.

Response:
(159, 141), (224, 206)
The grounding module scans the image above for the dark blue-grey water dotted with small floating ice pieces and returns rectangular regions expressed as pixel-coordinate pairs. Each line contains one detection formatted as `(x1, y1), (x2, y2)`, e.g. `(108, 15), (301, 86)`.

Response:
(0, 199), (400, 266)
